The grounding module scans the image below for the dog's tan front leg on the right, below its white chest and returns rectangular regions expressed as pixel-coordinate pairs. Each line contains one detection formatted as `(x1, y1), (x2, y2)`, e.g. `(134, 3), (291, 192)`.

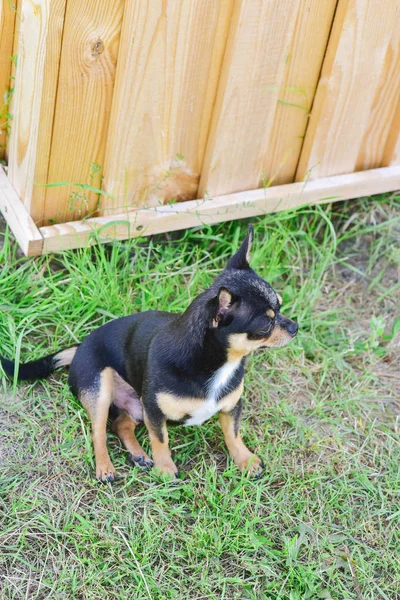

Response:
(219, 400), (263, 477)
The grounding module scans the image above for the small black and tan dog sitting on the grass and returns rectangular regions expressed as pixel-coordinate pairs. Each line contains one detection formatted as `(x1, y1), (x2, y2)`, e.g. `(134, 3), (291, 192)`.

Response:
(0, 227), (298, 482)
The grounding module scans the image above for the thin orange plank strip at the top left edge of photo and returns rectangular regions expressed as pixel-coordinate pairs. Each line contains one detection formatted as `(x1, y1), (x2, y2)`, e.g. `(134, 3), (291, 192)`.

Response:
(0, 0), (16, 160)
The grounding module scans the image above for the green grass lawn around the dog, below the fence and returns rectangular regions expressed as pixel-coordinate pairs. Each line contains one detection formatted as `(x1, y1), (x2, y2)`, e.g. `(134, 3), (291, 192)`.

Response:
(0, 194), (400, 600)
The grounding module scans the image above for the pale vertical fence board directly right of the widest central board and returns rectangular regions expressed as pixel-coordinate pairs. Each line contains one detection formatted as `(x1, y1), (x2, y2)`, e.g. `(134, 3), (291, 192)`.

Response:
(199, 0), (308, 196)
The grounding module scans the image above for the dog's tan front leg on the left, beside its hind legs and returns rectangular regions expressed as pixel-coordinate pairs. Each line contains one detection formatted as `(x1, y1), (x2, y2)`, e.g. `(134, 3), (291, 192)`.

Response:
(144, 407), (178, 477)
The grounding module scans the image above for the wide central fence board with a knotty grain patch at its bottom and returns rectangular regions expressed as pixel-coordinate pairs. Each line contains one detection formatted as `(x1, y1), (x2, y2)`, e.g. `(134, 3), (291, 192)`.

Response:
(101, 0), (233, 214)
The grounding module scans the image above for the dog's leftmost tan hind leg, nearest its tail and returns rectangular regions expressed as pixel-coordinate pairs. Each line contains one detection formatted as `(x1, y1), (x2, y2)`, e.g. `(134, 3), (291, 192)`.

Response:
(80, 367), (115, 481)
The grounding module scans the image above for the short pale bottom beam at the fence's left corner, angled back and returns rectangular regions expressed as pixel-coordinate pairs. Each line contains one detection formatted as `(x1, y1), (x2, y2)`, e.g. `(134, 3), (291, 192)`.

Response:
(0, 166), (43, 256)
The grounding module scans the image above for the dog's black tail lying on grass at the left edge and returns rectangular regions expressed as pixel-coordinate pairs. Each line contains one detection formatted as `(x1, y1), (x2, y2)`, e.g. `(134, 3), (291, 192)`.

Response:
(0, 344), (79, 381)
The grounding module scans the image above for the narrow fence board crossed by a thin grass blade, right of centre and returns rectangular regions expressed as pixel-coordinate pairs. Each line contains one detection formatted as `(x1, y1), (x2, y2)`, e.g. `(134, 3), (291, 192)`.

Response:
(260, 0), (337, 185)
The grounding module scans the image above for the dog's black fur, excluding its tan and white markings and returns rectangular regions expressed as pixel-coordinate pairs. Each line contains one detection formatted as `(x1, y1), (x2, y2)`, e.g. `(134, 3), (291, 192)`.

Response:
(1, 228), (297, 480)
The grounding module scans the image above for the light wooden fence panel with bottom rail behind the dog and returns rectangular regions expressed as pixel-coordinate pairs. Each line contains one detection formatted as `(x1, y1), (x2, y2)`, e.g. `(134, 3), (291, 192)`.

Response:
(0, 0), (400, 254)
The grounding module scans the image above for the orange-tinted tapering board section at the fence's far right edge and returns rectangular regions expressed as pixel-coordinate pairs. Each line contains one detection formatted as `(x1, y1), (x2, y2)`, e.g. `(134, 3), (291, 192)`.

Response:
(355, 19), (400, 171)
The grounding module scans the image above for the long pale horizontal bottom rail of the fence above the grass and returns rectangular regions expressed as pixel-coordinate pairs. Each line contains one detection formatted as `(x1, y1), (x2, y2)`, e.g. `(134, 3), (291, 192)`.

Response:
(40, 166), (400, 253)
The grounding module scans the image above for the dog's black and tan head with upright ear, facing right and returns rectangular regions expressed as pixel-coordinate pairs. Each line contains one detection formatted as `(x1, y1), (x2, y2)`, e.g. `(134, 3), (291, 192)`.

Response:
(207, 227), (298, 359)
